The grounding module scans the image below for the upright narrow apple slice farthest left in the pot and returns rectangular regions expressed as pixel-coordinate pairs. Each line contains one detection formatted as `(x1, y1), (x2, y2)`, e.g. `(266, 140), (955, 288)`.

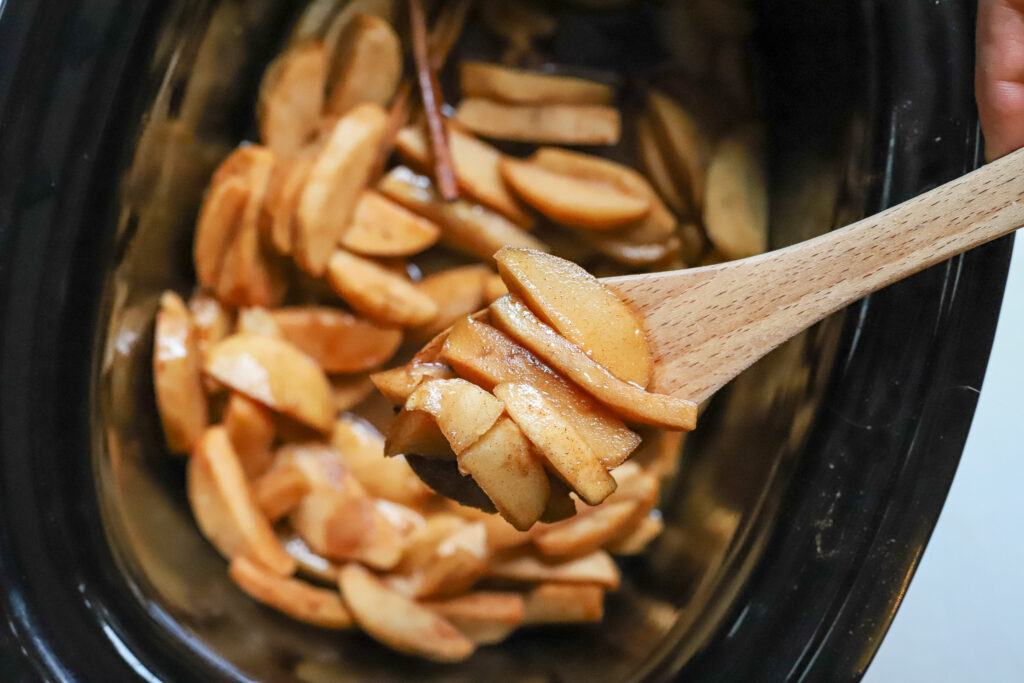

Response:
(153, 291), (209, 453)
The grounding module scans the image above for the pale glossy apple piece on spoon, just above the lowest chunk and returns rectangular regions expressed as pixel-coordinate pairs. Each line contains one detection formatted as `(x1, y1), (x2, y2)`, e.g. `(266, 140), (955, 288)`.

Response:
(404, 379), (505, 456)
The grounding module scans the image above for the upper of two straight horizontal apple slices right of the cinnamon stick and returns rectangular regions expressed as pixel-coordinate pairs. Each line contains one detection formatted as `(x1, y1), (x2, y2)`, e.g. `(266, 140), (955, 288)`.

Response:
(459, 61), (615, 104)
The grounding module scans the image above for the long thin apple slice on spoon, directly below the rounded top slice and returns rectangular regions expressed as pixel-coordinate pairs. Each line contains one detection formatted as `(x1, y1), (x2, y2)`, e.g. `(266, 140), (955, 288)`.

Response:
(489, 295), (697, 431)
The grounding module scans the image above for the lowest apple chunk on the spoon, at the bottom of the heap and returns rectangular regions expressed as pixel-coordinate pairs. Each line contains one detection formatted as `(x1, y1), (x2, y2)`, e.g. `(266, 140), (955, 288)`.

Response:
(459, 417), (550, 530)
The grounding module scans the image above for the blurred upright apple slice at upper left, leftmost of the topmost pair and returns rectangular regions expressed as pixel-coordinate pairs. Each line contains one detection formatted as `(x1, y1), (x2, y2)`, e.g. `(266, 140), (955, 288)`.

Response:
(257, 42), (327, 156)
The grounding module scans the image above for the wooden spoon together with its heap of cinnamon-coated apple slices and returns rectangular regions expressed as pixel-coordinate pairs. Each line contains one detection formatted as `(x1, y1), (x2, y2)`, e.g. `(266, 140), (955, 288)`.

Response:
(373, 145), (1024, 529)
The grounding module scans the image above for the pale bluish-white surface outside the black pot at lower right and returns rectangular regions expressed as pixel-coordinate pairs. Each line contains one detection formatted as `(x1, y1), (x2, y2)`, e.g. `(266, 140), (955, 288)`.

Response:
(864, 234), (1024, 683)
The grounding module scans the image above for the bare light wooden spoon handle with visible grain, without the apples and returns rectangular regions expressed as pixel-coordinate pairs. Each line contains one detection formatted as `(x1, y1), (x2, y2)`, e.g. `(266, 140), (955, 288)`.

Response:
(607, 144), (1024, 400)
